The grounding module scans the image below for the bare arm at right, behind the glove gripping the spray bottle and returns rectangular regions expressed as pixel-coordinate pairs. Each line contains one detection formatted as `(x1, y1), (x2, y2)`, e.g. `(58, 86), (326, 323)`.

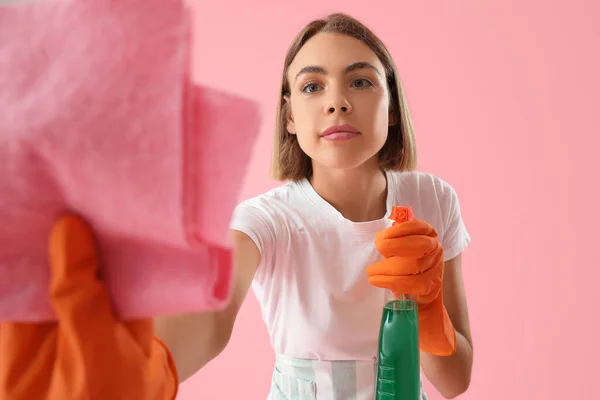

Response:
(421, 255), (473, 399)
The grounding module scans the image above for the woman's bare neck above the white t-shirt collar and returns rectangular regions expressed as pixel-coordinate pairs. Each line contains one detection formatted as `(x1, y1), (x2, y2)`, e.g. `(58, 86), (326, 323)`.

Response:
(310, 160), (387, 222)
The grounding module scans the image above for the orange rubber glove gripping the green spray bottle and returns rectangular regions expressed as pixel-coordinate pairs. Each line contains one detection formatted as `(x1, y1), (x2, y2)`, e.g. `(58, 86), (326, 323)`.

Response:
(367, 207), (456, 356)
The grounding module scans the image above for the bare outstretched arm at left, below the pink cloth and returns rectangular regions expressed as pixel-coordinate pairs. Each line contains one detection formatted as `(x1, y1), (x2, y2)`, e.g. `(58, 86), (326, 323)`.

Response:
(154, 231), (261, 382)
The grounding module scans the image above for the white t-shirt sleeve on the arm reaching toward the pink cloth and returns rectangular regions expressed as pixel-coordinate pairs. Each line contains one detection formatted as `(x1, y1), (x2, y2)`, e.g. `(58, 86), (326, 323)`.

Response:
(229, 200), (276, 276)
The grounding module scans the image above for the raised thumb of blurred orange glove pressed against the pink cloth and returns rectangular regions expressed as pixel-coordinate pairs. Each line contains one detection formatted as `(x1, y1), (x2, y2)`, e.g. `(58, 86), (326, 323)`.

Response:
(48, 215), (114, 334)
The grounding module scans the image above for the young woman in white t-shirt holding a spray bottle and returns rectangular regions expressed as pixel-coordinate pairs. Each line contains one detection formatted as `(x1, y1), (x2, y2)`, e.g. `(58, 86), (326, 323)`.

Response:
(157, 14), (473, 400)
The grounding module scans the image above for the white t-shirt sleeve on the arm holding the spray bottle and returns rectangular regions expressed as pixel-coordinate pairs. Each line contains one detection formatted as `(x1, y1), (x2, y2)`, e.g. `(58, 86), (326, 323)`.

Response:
(439, 181), (471, 261)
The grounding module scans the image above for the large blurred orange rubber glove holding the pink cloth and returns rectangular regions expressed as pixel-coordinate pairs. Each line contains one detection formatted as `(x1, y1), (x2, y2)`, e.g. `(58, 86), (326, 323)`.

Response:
(0, 216), (178, 400)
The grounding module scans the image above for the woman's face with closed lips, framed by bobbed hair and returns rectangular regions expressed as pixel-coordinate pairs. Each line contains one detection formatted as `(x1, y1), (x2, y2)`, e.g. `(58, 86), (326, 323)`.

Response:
(287, 33), (390, 173)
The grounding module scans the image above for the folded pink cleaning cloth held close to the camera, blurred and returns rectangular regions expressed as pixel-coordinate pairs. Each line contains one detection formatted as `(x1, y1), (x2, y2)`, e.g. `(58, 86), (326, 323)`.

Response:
(0, 0), (259, 322)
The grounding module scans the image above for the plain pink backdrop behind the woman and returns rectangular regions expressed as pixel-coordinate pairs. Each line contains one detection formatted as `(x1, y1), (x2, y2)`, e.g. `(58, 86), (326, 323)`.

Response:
(178, 0), (600, 400)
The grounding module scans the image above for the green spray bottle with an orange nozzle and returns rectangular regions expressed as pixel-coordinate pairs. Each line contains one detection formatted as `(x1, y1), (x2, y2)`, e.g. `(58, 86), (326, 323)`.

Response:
(375, 207), (421, 400)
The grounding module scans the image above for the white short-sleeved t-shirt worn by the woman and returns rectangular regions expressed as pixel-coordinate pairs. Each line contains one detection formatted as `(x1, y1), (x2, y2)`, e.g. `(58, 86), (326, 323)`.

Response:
(231, 172), (470, 361)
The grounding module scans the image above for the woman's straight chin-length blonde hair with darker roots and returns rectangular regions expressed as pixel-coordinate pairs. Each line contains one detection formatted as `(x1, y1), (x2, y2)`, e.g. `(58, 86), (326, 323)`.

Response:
(271, 13), (417, 181)
